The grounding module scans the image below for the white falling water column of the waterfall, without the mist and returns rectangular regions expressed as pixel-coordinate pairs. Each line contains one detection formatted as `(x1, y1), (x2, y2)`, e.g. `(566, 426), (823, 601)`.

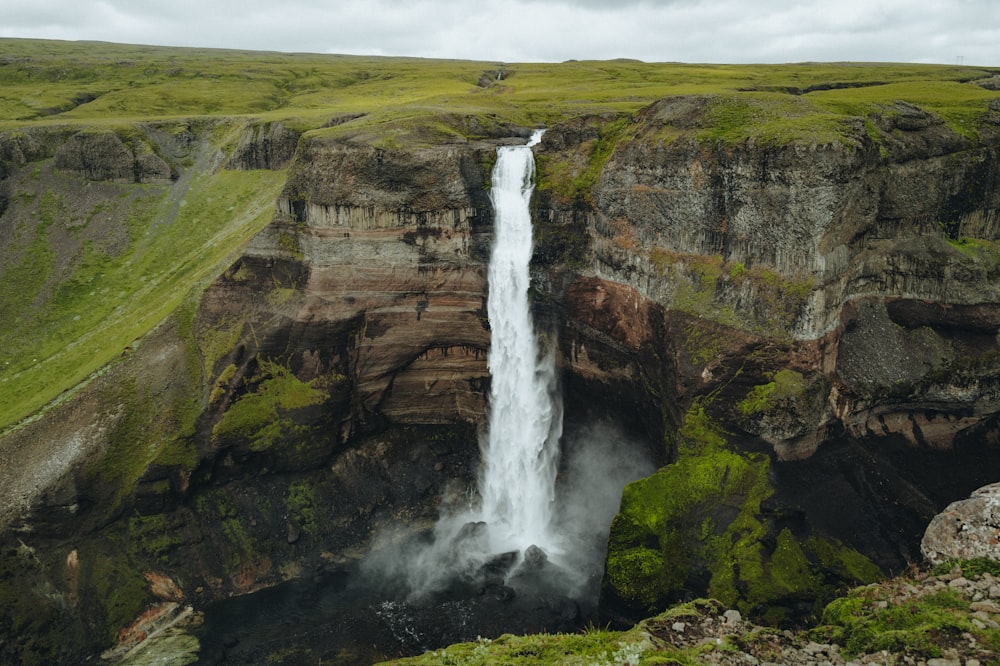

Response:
(479, 131), (562, 557)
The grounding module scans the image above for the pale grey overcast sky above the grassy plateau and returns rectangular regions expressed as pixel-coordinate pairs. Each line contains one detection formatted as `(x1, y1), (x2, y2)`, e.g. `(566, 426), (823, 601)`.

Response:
(0, 0), (1000, 66)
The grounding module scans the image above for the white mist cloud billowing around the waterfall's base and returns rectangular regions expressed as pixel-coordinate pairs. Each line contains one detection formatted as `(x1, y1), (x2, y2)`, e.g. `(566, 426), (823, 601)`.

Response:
(362, 424), (656, 600)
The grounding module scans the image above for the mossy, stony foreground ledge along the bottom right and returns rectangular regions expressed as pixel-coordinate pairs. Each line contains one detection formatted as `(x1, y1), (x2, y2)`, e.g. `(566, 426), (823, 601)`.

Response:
(385, 560), (1000, 666)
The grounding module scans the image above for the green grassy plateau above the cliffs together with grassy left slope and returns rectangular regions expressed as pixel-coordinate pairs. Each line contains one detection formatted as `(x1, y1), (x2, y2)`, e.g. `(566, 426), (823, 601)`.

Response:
(0, 39), (998, 430)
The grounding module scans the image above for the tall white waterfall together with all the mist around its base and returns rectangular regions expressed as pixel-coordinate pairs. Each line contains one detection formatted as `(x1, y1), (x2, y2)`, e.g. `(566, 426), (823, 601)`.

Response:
(362, 131), (656, 608)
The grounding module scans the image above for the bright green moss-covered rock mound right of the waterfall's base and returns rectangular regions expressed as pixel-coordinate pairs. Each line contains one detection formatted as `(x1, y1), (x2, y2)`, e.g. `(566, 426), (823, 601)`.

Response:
(604, 402), (881, 624)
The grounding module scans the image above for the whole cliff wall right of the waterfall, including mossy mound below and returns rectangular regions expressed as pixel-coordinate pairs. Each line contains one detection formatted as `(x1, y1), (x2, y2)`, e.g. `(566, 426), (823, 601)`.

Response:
(539, 98), (1000, 619)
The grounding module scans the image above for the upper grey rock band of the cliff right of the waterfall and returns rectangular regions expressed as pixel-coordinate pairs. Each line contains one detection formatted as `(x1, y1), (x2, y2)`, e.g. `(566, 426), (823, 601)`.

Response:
(556, 98), (1000, 339)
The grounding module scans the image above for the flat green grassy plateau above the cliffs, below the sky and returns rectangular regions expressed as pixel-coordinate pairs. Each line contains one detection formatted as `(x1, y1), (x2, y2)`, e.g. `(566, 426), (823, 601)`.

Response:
(0, 39), (1000, 138)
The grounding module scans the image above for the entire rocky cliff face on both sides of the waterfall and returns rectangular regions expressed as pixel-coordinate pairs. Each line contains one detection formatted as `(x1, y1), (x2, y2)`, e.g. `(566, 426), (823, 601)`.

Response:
(0, 93), (1000, 661)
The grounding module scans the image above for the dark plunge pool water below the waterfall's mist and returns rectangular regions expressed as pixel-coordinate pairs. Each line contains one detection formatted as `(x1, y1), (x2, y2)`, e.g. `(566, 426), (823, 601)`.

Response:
(194, 548), (596, 665)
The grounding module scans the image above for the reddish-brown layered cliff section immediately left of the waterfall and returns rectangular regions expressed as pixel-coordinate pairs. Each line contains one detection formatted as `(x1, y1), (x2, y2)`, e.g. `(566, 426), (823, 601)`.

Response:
(202, 136), (500, 430)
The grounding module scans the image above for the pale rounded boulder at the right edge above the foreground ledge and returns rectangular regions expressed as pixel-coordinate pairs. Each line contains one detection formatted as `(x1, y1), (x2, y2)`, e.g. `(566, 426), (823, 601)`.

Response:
(920, 483), (1000, 564)
